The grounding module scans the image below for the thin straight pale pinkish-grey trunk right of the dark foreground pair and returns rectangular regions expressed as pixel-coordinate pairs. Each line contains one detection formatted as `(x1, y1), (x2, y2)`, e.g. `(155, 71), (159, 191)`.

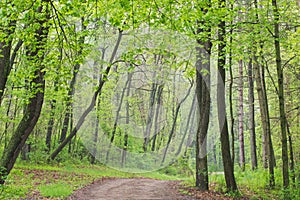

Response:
(239, 60), (245, 171)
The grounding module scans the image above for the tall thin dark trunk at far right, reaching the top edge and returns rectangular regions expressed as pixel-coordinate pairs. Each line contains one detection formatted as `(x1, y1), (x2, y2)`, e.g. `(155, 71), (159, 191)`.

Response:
(272, 0), (289, 188)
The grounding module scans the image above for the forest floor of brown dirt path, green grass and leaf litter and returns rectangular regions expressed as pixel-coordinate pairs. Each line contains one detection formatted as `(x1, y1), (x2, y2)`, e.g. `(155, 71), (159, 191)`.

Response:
(0, 164), (255, 200)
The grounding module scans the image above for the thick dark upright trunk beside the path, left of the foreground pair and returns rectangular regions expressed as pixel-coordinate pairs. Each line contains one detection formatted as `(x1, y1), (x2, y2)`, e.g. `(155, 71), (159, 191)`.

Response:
(196, 16), (212, 191)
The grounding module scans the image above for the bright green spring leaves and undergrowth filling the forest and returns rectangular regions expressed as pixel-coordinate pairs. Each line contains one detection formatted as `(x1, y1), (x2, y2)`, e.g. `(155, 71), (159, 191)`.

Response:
(0, 0), (300, 199)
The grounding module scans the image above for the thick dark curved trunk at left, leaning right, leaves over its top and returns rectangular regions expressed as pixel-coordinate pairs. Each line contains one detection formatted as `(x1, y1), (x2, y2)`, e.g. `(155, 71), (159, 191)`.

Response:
(0, 4), (50, 184)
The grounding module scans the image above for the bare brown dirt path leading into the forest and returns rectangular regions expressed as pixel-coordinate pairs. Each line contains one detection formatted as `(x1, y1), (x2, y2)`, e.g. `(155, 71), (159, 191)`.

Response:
(69, 178), (193, 200)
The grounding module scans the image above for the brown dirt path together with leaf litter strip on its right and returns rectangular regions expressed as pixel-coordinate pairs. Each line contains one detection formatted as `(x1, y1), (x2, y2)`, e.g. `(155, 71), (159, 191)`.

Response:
(68, 178), (244, 200)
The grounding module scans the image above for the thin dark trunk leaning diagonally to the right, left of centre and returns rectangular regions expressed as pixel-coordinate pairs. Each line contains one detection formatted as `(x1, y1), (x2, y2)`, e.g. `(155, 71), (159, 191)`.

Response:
(49, 30), (123, 160)
